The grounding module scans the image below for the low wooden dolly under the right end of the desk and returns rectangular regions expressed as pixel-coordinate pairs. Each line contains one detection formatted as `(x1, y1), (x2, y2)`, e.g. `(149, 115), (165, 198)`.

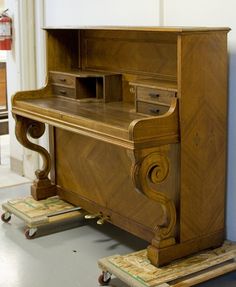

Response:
(98, 241), (236, 287)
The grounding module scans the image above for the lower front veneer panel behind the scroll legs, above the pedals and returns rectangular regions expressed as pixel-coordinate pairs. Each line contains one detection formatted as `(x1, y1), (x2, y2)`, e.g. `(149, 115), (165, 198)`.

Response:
(56, 129), (178, 240)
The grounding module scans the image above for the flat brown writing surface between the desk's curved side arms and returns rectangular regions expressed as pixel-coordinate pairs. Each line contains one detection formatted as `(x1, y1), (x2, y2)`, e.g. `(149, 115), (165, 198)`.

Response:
(13, 97), (147, 140)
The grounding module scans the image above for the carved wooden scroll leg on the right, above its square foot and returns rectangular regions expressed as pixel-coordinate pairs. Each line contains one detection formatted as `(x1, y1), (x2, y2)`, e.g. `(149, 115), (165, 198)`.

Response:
(132, 152), (176, 248)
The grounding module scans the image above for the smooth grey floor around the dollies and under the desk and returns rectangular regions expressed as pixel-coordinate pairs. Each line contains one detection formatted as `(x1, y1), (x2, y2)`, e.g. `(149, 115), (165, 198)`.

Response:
(0, 136), (236, 287)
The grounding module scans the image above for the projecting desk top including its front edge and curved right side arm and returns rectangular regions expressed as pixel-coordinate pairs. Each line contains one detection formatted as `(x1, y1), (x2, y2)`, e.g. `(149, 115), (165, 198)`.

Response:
(13, 97), (177, 150)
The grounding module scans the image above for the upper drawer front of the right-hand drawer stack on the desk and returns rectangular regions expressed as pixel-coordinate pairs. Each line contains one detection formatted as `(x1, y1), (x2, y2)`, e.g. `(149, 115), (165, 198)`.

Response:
(137, 87), (175, 105)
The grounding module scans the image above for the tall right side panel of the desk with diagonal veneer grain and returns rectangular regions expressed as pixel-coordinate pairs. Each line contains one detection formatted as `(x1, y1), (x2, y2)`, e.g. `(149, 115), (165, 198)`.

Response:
(179, 32), (227, 241)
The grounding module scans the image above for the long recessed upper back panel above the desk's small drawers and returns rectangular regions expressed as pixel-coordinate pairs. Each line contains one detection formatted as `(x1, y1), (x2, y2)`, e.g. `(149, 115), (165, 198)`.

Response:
(81, 30), (177, 78)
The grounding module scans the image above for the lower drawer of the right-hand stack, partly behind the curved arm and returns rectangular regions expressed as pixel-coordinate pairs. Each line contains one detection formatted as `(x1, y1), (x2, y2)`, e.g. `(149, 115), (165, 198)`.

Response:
(136, 102), (169, 116)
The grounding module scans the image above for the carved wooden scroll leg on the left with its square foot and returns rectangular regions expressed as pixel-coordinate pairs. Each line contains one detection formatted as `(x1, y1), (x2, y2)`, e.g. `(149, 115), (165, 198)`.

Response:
(14, 115), (57, 200)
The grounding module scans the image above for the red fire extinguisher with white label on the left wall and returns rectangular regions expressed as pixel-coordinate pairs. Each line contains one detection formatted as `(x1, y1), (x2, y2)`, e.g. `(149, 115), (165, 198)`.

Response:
(0, 9), (12, 50)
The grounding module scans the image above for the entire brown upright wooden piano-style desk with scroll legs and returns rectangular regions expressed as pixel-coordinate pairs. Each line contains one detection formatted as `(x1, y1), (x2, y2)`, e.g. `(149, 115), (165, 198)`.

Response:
(12, 27), (229, 265)
